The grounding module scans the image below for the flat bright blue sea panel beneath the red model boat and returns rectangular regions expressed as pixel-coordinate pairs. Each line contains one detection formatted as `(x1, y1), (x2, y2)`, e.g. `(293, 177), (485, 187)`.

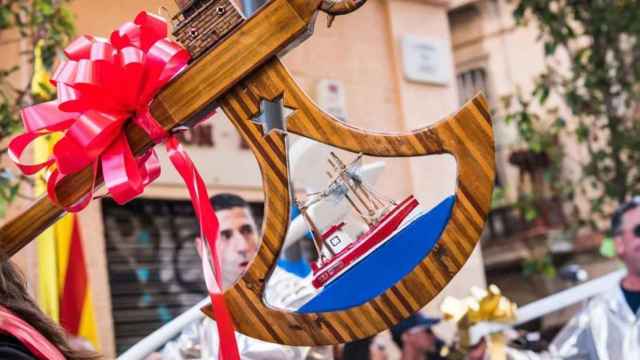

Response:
(298, 196), (455, 313)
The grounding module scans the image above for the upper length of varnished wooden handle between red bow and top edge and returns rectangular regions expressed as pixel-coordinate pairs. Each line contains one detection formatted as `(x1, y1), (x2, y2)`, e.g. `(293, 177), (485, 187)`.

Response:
(151, 0), (318, 126)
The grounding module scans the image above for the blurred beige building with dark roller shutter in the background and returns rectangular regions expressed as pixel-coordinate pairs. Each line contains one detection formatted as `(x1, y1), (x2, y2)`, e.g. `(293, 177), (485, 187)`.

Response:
(0, 0), (615, 358)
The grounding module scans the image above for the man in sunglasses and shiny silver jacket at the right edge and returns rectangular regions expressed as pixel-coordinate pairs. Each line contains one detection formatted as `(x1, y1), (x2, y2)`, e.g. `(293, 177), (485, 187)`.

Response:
(507, 197), (640, 360)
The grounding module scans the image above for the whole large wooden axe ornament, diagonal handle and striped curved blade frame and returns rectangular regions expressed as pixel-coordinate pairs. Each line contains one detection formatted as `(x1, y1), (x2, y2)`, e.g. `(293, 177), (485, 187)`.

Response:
(0, 0), (495, 346)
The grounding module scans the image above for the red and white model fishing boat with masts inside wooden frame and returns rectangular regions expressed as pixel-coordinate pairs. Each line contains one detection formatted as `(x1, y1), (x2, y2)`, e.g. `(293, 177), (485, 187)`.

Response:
(299, 152), (418, 288)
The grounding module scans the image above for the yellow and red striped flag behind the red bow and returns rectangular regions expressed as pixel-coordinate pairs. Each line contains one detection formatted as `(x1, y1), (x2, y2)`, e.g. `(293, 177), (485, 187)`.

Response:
(31, 43), (99, 349)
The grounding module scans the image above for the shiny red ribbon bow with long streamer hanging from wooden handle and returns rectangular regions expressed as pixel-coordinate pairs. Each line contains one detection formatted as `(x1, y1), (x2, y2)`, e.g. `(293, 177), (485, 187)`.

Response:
(9, 11), (240, 360)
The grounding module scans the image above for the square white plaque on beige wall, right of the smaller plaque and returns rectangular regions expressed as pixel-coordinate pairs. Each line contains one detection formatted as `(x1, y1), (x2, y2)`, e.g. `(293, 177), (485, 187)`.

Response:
(401, 35), (451, 85)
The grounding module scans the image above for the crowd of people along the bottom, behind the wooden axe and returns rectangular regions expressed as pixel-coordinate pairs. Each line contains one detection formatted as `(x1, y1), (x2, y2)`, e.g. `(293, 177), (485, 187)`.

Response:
(0, 194), (640, 360)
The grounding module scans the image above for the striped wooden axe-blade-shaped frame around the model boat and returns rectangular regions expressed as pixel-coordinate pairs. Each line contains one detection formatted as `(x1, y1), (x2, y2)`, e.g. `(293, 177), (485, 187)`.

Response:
(203, 59), (495, 346)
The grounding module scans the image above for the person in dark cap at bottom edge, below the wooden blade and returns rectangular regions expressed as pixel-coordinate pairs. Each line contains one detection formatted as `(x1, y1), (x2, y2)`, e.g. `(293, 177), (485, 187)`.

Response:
(391, 313), (444, 360)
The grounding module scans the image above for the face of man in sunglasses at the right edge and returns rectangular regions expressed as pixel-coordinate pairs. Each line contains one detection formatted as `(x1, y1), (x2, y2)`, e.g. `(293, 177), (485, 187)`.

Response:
(615, 207), (640, 276)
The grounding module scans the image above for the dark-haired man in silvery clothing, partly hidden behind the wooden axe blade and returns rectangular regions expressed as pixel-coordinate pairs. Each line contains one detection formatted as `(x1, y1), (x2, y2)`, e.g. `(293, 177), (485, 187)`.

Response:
(158, 194), (331, 360)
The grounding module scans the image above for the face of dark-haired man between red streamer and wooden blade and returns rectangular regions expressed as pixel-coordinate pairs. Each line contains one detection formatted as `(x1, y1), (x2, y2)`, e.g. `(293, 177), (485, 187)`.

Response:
(216, 207), (258, 288)
